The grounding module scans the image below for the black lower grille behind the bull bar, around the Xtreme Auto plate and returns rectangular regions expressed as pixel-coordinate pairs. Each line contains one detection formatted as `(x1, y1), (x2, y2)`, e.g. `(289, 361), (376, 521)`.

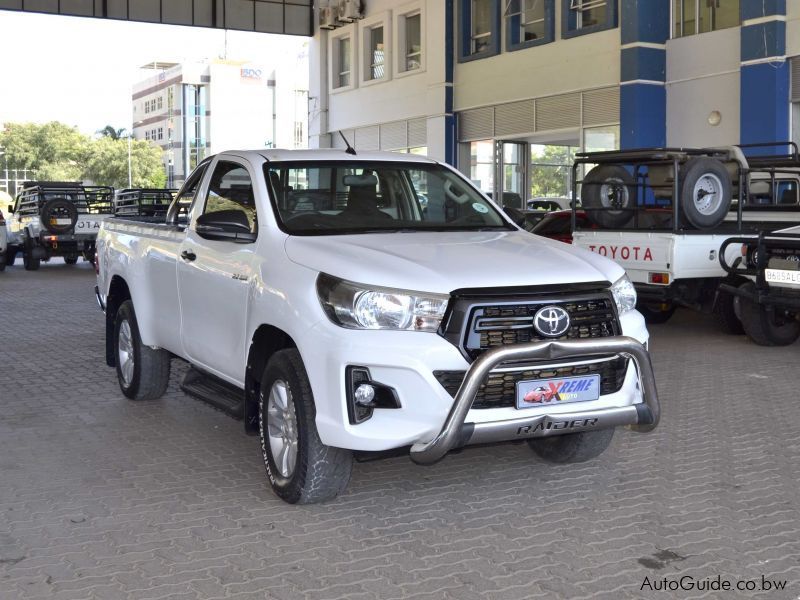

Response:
(433, 357), (628, 408)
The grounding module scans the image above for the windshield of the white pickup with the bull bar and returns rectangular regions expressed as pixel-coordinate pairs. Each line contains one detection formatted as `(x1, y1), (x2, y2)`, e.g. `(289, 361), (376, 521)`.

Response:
(264, 161), (514, 235)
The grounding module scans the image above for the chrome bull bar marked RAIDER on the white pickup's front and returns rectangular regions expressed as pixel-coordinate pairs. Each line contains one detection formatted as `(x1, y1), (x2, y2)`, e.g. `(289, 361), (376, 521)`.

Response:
(411, 336), (661, 464)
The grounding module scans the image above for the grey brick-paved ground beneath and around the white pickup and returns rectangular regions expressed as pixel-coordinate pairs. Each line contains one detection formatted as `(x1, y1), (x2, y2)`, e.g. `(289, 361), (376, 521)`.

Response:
(0, 262), (800, 600)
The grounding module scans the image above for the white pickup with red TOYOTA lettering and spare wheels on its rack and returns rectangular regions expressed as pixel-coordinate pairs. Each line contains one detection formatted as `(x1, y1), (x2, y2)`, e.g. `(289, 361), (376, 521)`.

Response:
(573, 143), (800, 333)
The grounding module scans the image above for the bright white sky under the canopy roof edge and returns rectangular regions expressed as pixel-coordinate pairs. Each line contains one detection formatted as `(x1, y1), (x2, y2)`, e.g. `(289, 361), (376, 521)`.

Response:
(0, 10), (306, 134)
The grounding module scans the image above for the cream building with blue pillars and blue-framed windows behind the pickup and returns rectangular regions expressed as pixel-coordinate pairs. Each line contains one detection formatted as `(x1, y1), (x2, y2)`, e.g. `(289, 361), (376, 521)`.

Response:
(310, 0), (800, 204)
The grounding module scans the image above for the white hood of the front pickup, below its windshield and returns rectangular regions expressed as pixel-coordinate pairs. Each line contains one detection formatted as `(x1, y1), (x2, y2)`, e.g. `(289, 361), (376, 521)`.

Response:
(285, 231), (624, 294)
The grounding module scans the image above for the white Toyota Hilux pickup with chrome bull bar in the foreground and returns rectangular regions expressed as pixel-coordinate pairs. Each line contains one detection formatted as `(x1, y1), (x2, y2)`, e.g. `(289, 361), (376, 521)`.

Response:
(96, 150), (659, 503)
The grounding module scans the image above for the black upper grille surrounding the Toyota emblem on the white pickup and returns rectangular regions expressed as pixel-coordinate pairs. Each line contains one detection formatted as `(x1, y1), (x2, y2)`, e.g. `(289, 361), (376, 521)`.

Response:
(456, 294), (619, 359)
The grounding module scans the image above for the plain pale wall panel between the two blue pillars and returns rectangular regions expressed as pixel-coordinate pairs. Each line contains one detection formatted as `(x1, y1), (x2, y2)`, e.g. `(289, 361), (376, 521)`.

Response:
(667, 27), (741, 147)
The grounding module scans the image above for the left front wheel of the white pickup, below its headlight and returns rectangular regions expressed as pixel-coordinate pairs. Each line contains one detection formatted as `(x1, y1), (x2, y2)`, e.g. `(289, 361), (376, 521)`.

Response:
(258, 349), (353, 504)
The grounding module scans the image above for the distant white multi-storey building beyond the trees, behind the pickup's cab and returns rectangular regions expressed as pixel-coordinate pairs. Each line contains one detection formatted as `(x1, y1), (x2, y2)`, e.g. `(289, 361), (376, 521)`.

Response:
(132, 52), (308, 187)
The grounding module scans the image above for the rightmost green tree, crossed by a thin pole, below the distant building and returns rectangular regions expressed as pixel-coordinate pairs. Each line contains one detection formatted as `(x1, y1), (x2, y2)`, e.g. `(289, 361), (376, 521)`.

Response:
(84, 137), (167, 188)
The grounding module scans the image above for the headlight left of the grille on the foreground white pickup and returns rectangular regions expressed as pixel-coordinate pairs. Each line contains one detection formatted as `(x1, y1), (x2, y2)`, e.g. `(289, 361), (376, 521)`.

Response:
(317, 273), (449, 331)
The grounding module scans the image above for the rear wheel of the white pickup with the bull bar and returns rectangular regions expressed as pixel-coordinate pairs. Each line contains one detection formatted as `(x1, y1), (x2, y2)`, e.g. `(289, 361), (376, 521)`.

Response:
(114, 300), (171, 400)
